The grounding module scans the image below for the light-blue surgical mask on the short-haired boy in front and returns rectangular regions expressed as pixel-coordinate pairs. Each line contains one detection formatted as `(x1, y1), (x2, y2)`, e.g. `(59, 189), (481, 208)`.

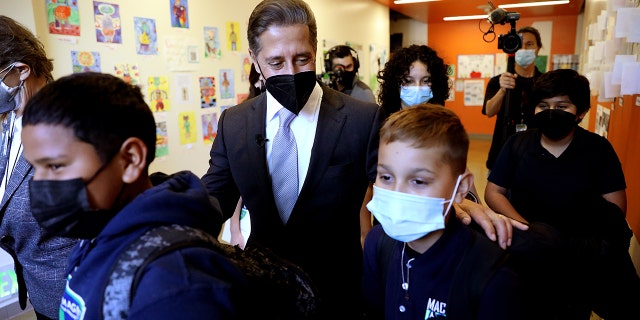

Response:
(367, 175), (462, 242)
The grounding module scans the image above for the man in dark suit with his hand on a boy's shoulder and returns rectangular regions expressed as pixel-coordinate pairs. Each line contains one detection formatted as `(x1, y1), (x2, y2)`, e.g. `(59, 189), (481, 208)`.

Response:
(202, 0), (383, 319)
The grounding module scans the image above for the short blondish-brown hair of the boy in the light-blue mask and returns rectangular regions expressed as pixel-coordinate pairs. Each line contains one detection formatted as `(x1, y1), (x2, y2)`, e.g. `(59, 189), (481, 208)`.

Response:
(380, 103), (469, 175)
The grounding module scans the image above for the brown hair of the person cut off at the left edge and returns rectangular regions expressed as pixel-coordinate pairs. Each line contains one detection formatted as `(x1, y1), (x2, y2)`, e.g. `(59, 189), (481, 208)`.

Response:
(0, 15), (53, 81)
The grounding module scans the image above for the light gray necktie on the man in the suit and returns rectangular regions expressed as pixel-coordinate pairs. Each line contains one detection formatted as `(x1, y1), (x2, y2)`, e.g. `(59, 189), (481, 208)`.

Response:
(271, 108), (298, 224)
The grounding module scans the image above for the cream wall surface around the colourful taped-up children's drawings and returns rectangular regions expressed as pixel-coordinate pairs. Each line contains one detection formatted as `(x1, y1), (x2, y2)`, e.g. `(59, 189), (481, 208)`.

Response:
(5, 0), (389, 176)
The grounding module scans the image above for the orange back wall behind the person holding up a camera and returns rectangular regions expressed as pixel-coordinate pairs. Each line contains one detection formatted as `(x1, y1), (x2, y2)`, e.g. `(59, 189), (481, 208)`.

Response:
(428, 15), (578, 135)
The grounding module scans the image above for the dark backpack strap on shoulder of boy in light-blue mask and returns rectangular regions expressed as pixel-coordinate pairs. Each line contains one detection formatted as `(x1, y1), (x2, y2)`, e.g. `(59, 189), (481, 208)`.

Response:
(447, 230), (508, 320)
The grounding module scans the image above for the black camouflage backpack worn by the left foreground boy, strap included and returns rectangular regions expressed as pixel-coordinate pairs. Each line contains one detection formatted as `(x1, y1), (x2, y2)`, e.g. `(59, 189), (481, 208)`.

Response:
(102, 225), (319, 319)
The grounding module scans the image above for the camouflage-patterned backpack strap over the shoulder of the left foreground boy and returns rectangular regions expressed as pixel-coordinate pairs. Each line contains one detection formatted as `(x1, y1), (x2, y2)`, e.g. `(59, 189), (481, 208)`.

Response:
(102, 224), (217, 319)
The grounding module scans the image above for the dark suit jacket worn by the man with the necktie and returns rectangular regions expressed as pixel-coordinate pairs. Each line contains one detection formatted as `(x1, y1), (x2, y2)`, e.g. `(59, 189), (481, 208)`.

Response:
(202, 85), (384, 315)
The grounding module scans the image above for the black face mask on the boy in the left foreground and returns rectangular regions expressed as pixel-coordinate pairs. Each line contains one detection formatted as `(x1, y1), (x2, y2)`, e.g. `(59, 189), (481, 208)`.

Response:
(29, 159), (125, 239)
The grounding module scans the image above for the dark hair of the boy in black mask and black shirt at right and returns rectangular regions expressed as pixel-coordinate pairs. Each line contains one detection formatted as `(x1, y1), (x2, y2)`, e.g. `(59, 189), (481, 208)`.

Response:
(527, 69), (591, 115)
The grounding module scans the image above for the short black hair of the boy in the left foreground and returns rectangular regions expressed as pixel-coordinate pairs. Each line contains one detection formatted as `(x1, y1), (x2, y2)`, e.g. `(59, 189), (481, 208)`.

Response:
(22, 72), (156, 166)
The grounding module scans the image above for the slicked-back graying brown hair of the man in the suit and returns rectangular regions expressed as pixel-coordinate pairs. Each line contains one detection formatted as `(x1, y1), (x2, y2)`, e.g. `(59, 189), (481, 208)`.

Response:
(247, 0), (318, 56)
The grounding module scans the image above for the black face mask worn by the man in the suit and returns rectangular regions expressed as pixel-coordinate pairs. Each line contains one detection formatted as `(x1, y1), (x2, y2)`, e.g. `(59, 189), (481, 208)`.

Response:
(267, 71), (316, 115)
